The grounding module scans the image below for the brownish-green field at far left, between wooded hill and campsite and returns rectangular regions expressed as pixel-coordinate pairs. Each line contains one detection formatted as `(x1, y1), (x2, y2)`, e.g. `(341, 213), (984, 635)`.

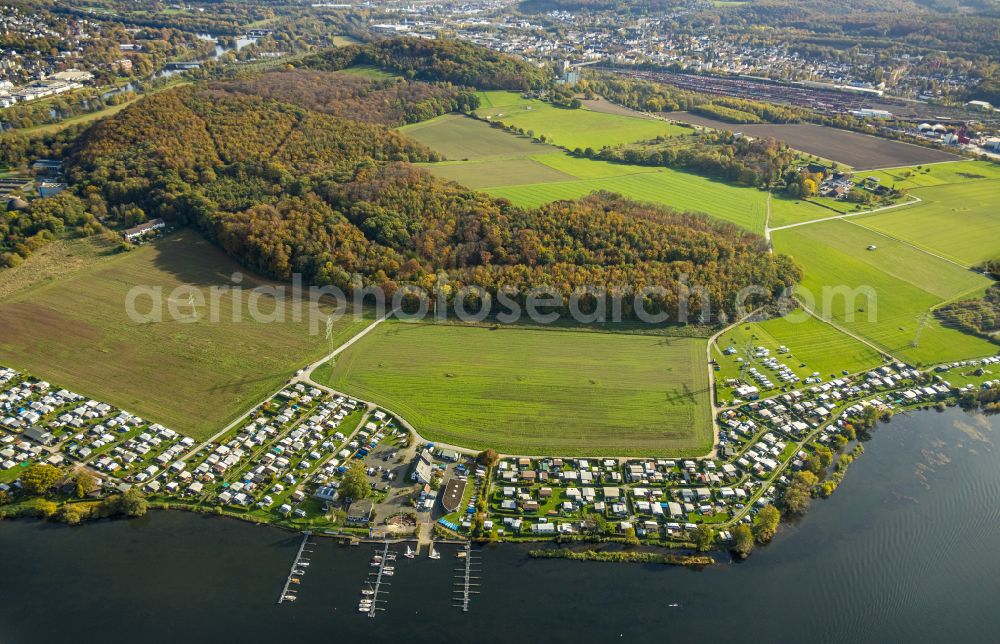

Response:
(0, 232), (365, 438)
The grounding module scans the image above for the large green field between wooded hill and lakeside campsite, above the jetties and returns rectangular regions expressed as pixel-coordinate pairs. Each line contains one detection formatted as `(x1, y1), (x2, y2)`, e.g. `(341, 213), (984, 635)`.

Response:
(313, 322), (712, 456)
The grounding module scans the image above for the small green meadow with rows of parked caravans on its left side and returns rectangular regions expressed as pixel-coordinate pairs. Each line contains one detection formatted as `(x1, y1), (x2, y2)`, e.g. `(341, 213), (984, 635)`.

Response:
(713, 309), (882, 399)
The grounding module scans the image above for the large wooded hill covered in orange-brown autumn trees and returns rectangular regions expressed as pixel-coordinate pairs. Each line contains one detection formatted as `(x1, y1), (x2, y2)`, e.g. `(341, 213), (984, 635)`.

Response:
(69, 80), (799, 321)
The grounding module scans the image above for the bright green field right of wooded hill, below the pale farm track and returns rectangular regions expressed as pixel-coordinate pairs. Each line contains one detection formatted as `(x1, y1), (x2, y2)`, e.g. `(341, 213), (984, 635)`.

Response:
(772, 221), (996, 364)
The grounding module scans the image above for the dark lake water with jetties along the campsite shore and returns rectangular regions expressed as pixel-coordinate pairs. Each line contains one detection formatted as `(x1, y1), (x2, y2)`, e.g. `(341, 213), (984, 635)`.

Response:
(0, 410), (1000, 644)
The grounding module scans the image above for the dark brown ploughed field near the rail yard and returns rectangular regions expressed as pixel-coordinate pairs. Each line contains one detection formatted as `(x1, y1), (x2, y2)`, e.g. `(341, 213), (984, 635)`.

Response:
(667, 112), (959, 170)
